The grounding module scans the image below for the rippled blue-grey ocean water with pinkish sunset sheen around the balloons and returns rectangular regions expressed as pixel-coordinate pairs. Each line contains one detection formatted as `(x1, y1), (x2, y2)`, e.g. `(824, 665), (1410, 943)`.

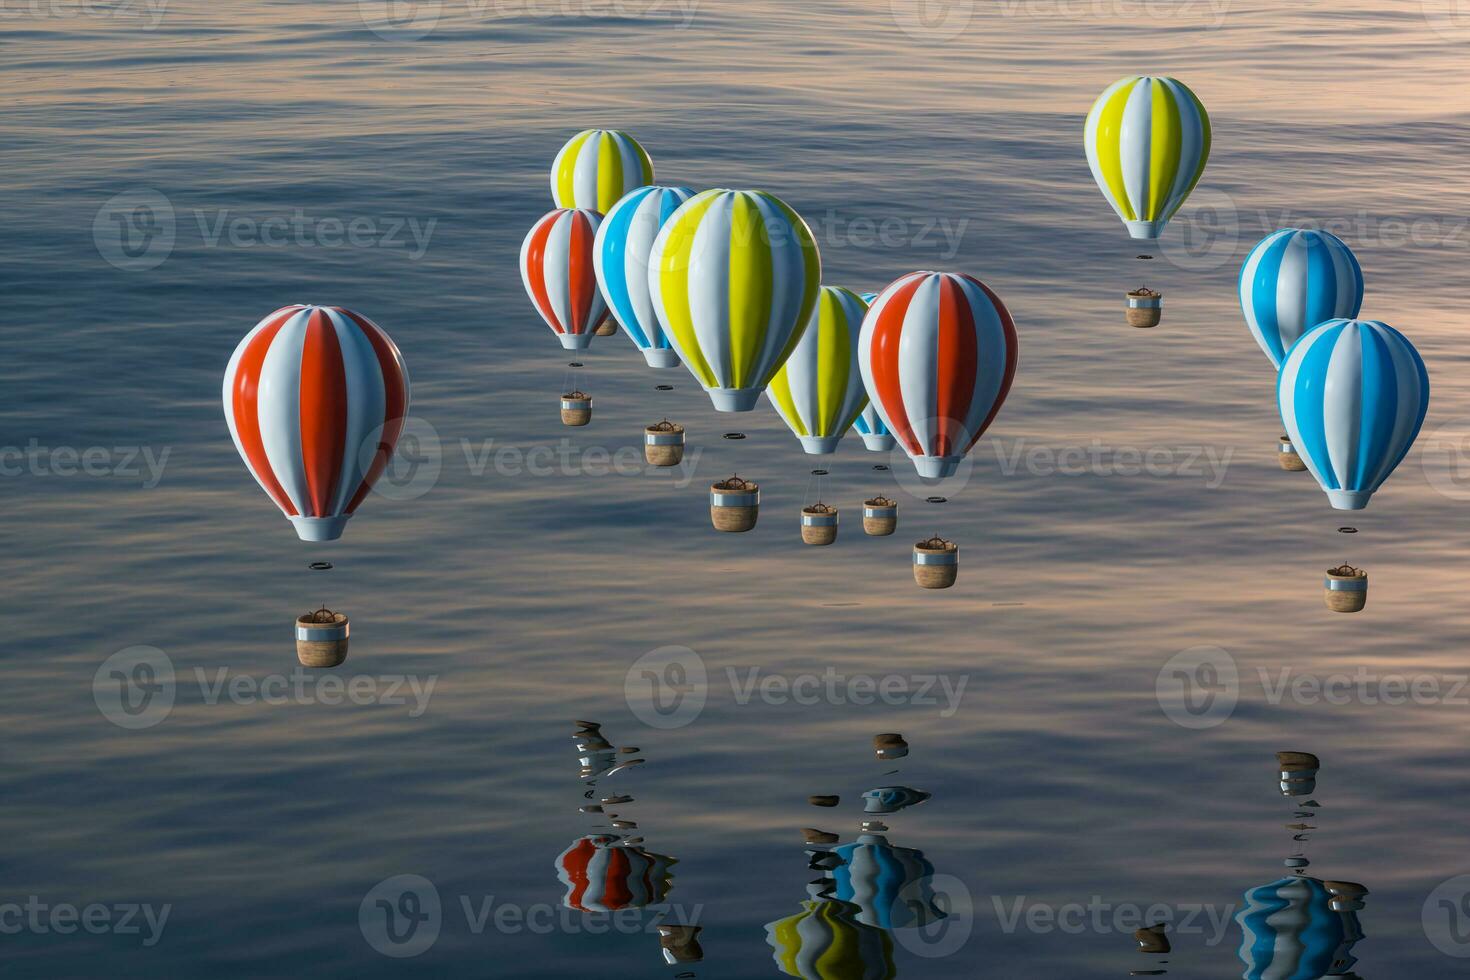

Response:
(0, 0), (1470, 979)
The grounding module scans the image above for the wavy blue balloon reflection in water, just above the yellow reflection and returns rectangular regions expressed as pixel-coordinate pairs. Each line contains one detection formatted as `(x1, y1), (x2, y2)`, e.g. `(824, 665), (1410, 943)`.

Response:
(832, 833), (945, 929)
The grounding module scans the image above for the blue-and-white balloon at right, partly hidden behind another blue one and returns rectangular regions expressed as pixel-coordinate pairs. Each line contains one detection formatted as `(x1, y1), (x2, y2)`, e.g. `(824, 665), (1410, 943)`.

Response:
(1241, 228), (1363, 369)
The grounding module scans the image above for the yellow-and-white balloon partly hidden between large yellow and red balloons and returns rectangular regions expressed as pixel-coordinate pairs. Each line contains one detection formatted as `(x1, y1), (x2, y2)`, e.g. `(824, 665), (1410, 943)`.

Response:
(766, 287), (867, 455)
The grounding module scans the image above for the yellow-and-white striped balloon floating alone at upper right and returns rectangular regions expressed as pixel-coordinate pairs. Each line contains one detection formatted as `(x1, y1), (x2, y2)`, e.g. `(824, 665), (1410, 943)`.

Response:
(1083, 75), (1210, 239)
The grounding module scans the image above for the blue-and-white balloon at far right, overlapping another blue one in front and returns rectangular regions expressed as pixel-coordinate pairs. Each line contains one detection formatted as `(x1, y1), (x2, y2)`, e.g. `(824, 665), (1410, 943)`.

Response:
(1276, 320), (1429, 510)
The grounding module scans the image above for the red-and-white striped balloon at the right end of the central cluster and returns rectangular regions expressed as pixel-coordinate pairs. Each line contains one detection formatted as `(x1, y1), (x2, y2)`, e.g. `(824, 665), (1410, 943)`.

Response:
(858, 272), (1017, 479)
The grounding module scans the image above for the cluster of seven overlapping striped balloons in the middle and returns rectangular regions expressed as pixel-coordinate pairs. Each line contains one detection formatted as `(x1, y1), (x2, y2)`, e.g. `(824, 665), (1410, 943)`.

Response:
(520, 129), (1017, 478)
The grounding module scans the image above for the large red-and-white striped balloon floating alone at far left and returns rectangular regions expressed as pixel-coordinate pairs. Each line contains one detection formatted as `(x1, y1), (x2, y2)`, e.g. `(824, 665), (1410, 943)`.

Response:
(223, 306), (409, 541)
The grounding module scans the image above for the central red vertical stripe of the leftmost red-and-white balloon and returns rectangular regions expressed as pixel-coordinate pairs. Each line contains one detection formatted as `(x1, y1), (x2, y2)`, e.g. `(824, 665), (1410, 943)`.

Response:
(300, 310), (347, 517)
